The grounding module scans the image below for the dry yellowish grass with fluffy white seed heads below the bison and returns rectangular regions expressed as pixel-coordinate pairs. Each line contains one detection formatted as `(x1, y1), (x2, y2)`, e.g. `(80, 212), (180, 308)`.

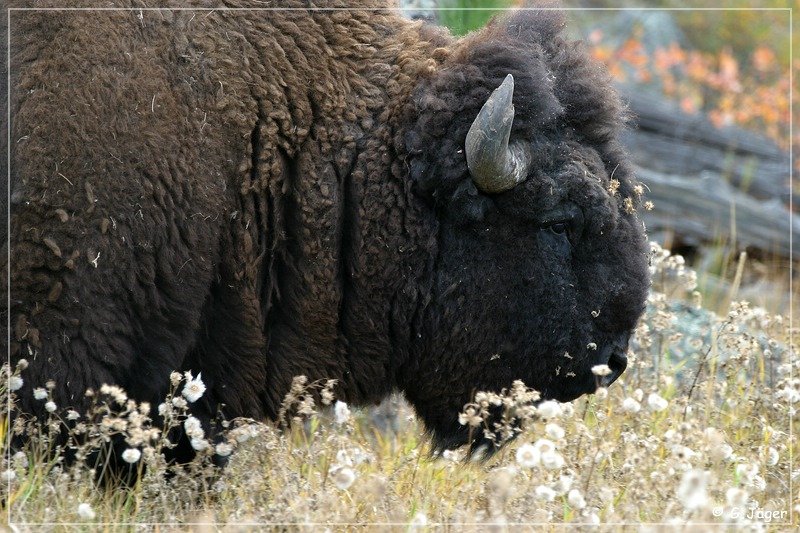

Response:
(0, 244), (800, 531)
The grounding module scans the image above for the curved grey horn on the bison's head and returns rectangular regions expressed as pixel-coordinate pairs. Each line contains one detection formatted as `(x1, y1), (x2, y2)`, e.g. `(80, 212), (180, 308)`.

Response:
(465, 74), (531, 193)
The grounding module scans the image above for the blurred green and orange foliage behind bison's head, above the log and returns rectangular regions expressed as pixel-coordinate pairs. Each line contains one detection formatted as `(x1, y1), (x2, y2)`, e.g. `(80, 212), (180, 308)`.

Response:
(416, 0), (800, 149)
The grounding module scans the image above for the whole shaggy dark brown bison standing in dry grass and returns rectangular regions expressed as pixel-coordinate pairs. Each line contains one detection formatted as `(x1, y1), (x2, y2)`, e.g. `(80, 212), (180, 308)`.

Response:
(9, 0), (648, 474)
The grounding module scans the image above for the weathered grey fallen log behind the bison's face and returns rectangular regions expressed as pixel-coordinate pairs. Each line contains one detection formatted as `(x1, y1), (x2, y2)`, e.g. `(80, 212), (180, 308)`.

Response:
(622, 87), (800, 259)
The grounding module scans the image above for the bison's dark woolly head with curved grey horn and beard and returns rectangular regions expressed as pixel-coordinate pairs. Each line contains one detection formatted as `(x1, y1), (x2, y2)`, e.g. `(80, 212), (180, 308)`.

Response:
(403, 12), (649, 447)
